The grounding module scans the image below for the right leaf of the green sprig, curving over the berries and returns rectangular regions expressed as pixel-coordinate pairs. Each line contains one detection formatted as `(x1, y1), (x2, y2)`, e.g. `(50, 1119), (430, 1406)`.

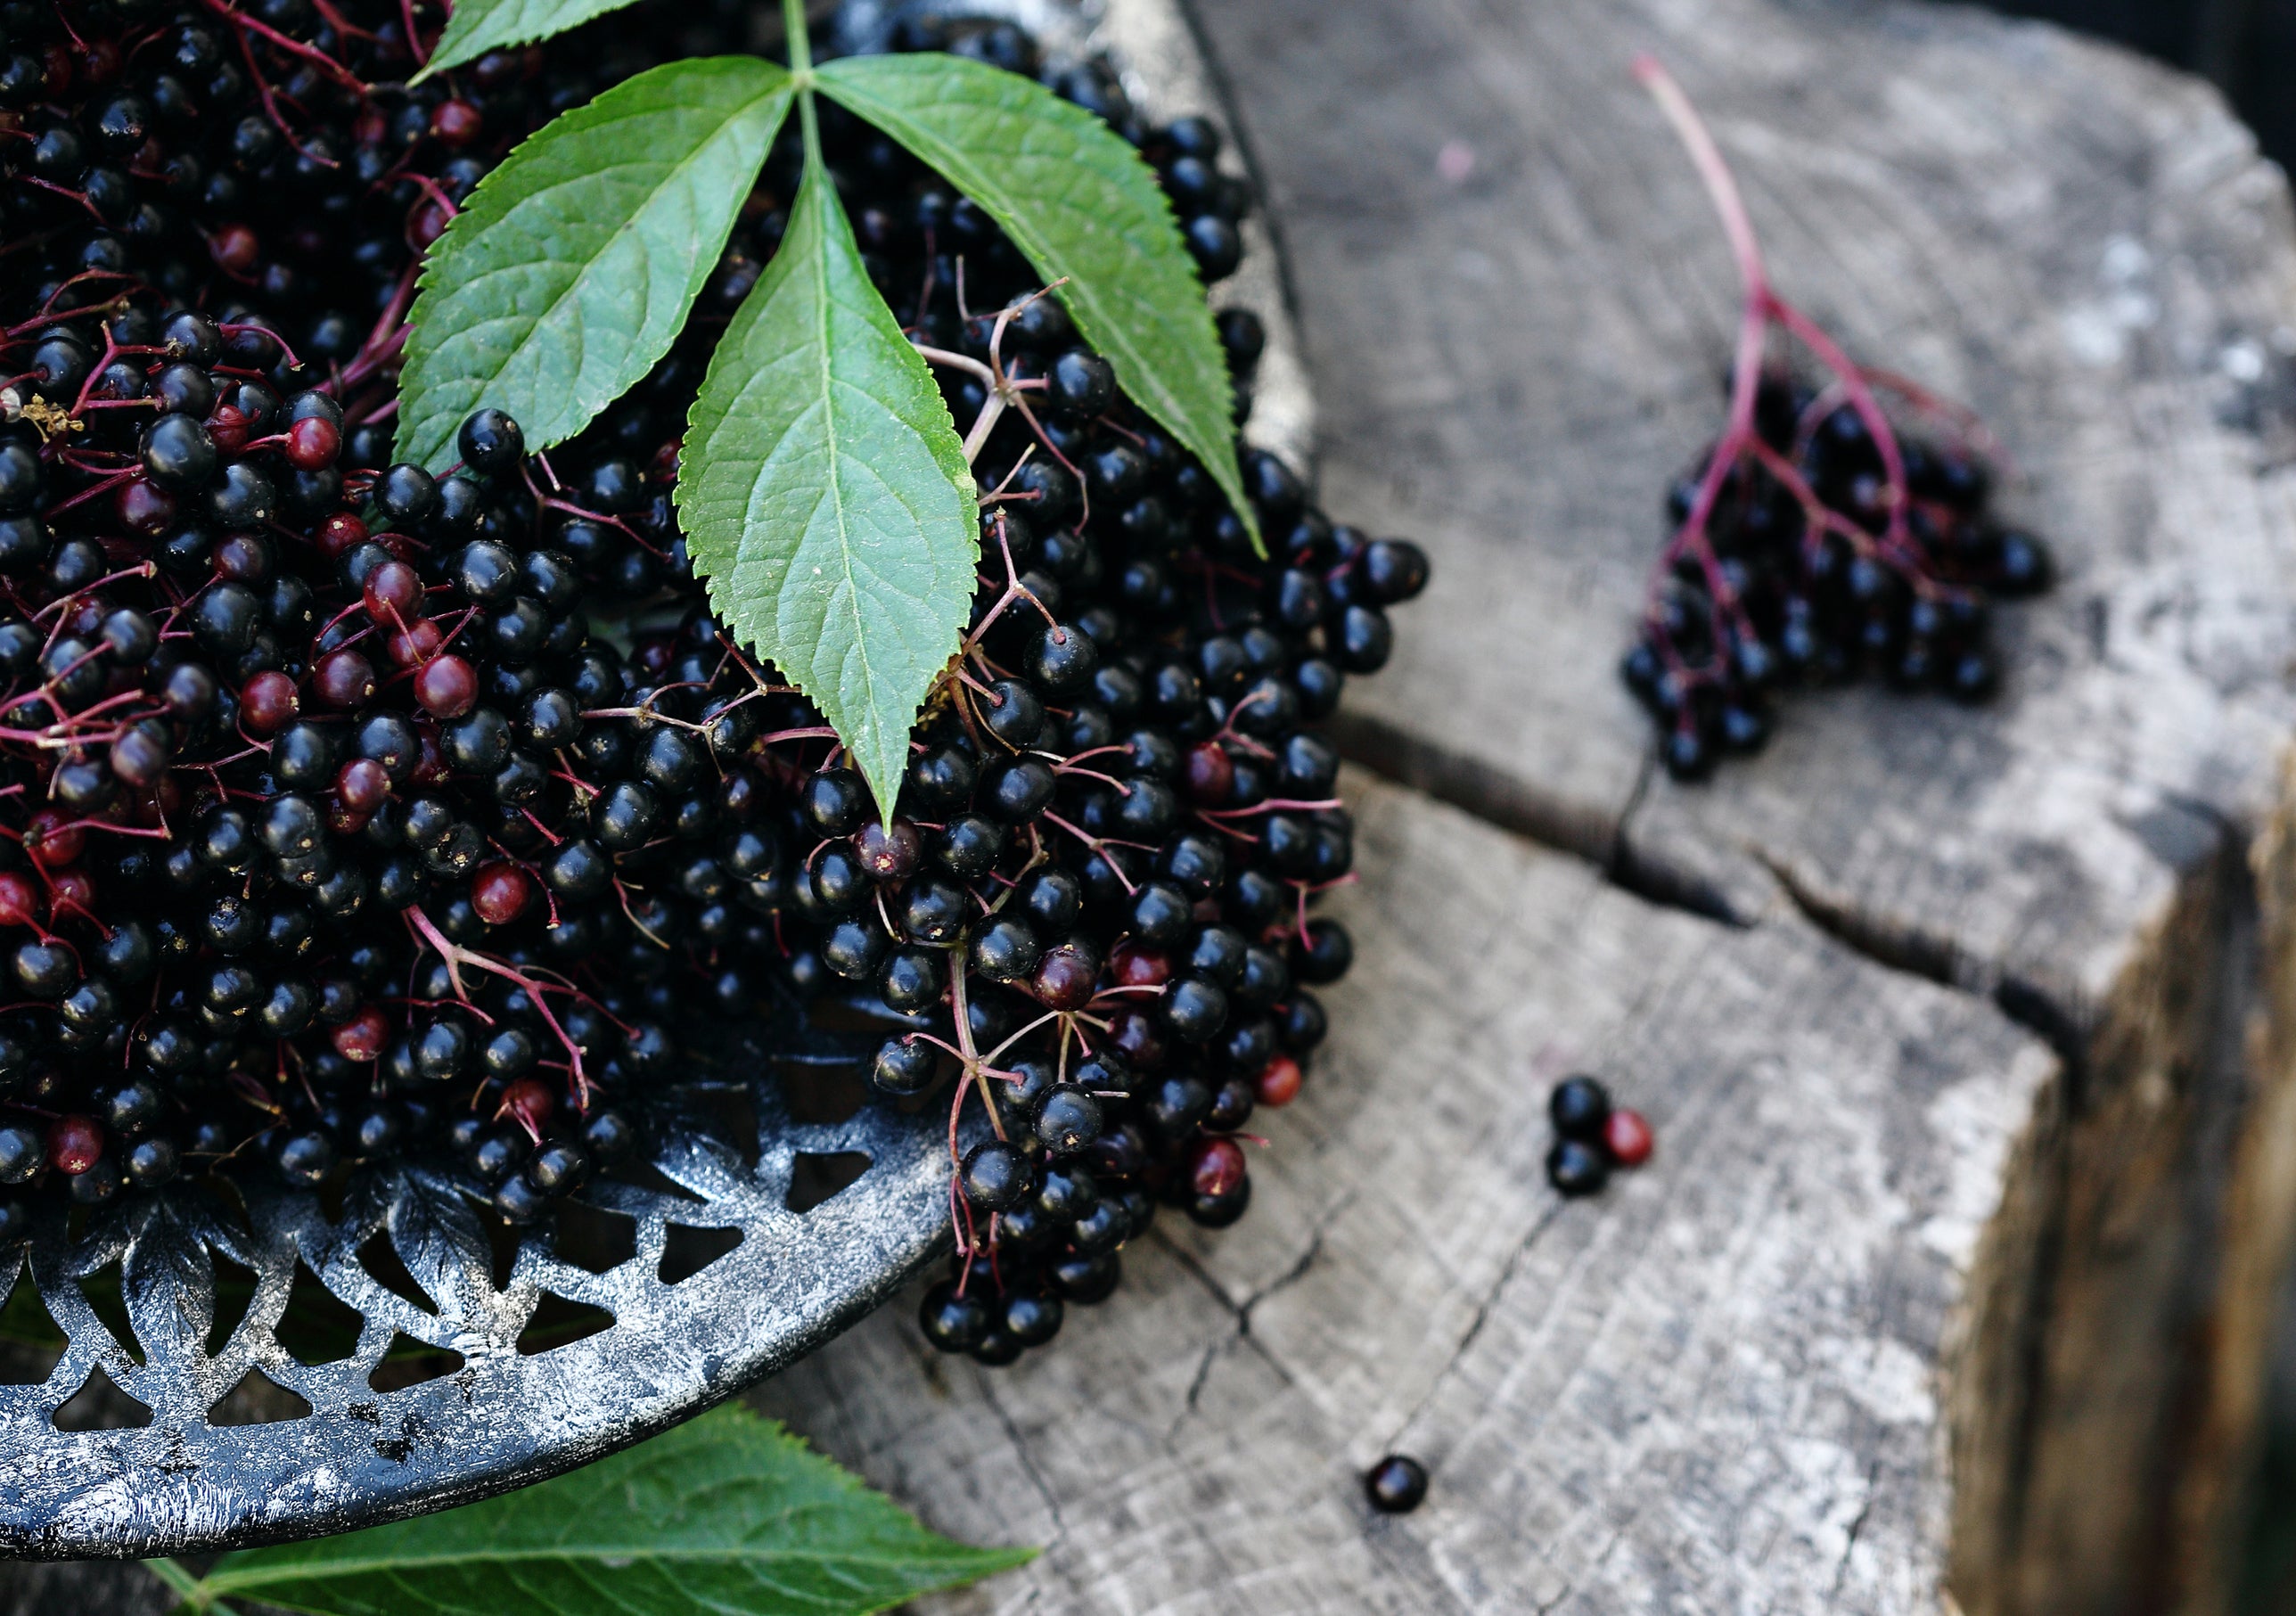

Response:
(817, 53), (1260, 544)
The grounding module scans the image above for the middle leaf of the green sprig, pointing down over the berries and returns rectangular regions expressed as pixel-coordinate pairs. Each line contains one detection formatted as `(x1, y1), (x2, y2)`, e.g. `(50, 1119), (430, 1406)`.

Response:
(677, 163), (980, 817)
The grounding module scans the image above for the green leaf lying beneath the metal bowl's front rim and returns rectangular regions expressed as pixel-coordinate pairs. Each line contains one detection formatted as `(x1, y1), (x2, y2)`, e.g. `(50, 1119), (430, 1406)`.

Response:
(200, 1407), (1036, 1616)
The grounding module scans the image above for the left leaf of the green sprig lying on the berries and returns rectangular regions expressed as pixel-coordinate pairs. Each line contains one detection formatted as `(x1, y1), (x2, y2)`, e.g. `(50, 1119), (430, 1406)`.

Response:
(398, 55), (790, 471)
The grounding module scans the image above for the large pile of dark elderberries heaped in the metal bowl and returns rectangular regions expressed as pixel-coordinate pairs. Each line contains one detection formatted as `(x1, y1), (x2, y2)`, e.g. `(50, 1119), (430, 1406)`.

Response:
(0, 0), (1426, 1364)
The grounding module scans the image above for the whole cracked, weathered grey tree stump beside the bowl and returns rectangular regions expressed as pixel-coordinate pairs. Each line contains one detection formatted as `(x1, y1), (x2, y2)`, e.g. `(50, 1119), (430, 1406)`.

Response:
(765, 0), (2296, 1616)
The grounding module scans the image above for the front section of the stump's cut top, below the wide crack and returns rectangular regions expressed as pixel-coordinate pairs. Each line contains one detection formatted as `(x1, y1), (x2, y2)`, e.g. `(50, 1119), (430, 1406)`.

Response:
(760, 785), (2060, 1613)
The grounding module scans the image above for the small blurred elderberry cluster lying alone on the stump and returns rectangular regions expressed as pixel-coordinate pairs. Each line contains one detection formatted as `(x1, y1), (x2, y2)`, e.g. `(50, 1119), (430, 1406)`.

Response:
(1621, 372), (2053, 781)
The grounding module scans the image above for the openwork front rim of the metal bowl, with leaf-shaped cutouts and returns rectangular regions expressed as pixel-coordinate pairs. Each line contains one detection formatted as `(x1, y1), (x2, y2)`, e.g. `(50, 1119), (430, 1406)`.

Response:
(0, 1029), (948, 1559)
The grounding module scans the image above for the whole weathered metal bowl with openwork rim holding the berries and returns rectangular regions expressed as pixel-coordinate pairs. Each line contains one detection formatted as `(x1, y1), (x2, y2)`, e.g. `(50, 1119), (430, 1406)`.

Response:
(0, 0), (1311, 1559)
